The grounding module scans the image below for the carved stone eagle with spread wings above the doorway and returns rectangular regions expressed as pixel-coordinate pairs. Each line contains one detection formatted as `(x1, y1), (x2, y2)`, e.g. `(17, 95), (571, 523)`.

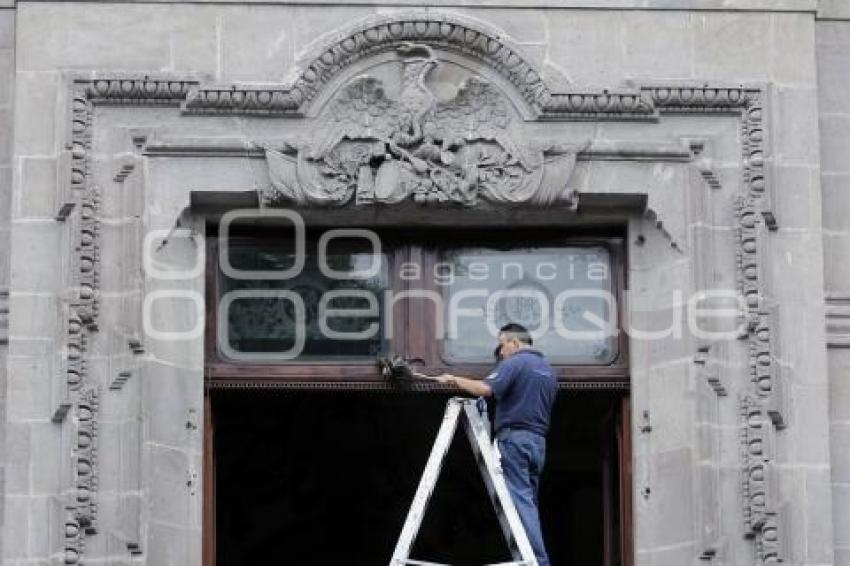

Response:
(266, 43), (578, 206)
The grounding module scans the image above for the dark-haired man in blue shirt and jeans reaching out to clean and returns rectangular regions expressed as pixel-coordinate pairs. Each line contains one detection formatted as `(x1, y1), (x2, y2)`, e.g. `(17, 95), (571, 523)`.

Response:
(437, 323), (558, 566)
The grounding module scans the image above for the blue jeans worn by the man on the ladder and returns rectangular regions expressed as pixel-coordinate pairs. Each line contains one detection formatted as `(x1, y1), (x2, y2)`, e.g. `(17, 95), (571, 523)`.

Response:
(497, 429), (549, 566)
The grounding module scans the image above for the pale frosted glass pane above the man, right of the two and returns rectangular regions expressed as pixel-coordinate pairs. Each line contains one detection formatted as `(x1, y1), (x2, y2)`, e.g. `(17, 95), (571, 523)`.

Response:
(435, 246), (617, 365)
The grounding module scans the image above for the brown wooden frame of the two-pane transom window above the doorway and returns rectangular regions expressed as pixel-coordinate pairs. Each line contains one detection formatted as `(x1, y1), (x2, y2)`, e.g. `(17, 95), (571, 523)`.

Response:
(205, 230), (629, 390)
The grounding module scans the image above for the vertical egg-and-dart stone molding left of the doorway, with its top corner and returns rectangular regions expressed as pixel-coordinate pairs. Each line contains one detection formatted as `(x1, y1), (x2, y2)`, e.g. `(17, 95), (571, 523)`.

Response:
(60, 76), (197, 565)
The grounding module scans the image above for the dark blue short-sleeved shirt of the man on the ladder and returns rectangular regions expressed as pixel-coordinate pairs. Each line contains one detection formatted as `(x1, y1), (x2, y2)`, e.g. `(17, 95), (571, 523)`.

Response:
(484, 348), (558, 436)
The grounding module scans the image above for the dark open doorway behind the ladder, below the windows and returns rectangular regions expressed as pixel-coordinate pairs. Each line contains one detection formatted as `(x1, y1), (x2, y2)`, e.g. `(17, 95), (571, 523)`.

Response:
(211, 390), (624, 566)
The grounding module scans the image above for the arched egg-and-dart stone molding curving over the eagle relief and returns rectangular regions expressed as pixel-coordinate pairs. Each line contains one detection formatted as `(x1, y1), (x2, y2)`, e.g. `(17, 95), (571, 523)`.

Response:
(176, 12), (758, 125)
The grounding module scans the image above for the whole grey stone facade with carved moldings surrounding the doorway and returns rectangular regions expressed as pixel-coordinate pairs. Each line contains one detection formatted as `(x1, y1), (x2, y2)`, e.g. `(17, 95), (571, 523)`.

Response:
(0, 0), (850, 566)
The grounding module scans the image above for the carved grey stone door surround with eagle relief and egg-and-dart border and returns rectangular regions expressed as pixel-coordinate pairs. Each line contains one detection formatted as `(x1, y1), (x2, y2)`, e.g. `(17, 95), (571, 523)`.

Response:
(57, 7), (789, 564)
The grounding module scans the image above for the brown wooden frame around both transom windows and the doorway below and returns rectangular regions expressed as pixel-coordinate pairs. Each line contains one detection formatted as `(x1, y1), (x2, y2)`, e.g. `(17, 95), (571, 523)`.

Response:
(203, 229), (634, 566)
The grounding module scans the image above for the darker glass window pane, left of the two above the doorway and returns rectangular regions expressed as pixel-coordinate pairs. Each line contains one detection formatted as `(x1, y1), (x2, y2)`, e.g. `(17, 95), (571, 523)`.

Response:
(219, 240), (389, 363)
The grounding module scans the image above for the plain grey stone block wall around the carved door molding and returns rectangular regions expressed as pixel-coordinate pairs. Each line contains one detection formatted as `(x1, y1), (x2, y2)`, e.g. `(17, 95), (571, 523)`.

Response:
(0, 0), (850, 566)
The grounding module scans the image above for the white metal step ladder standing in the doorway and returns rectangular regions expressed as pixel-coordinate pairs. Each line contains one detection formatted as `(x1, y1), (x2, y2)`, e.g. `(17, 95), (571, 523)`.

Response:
(390, 397), (537, 566)
